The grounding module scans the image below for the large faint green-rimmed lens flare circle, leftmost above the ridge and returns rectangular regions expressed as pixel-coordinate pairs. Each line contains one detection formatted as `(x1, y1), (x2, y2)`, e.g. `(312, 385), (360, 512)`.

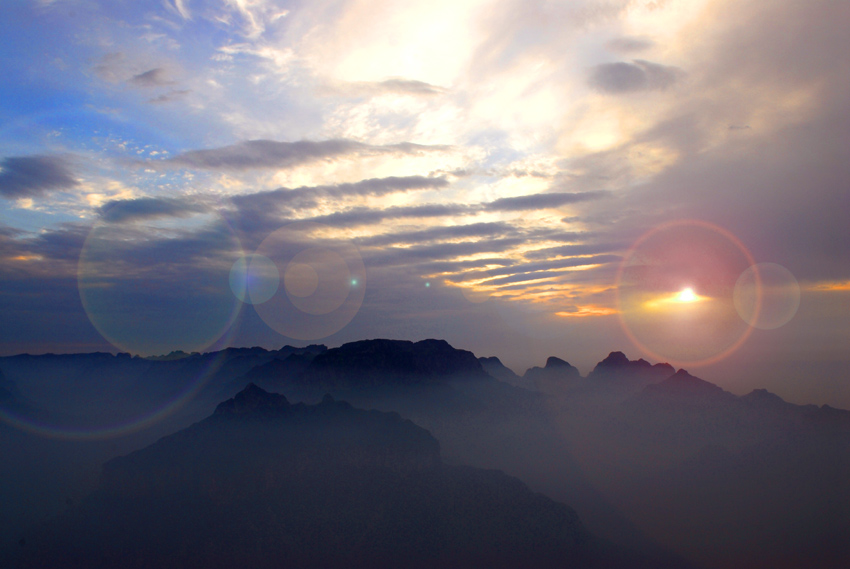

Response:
(77, 204), (242, 355)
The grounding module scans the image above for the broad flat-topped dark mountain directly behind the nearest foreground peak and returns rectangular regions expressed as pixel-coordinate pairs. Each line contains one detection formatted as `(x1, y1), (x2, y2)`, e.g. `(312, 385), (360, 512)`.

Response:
(214, 340), (688, 565)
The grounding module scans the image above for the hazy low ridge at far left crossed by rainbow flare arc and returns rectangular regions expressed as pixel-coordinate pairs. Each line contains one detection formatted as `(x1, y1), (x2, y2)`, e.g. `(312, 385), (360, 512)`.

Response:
(0, 346), (327, 543)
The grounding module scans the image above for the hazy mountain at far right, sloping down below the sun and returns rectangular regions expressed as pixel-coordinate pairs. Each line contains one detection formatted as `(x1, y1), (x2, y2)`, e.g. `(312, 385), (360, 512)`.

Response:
(574, 364), (850, 569)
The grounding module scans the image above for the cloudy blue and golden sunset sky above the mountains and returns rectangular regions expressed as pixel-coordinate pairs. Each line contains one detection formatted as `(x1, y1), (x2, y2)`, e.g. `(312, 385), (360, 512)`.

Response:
(0, 0), (850, 408)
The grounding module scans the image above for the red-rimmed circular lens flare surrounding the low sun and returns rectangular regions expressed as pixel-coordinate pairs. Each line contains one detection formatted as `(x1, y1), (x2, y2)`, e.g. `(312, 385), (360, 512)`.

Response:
(617, 220), (758, 366)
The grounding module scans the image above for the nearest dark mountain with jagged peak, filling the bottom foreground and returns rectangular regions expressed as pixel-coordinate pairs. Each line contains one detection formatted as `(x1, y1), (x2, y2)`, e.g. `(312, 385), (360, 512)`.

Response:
(4, 385), (676, 569)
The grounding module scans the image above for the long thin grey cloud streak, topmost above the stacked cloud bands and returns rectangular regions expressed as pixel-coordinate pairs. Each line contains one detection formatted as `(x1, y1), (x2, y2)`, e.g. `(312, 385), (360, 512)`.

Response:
(158, 139), (450, 170)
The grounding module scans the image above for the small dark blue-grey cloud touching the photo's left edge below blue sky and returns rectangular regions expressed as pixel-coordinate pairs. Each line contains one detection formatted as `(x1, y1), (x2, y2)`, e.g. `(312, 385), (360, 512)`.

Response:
(0, 155), (79, 199)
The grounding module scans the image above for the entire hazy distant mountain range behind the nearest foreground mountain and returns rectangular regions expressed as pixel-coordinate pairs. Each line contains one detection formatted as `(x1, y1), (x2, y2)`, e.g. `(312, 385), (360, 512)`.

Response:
(0, 340), (850, 569)
